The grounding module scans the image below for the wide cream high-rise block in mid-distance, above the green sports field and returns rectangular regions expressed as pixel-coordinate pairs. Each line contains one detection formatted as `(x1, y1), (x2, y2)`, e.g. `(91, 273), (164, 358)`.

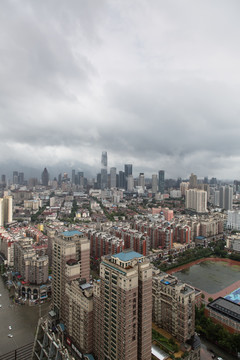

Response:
(185, 189), (207, 213)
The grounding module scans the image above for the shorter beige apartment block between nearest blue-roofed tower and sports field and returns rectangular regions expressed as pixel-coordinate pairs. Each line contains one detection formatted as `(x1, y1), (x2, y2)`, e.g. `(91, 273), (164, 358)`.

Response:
(153, 273), (195, 343)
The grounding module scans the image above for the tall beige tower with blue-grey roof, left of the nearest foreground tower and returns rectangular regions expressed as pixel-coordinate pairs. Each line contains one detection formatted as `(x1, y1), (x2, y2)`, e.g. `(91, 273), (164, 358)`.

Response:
(52, 230), (90, 323)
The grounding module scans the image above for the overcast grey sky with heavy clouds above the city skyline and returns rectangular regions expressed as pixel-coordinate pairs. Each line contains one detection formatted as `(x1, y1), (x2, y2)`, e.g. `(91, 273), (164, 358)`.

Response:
(0, 0), (240, 179)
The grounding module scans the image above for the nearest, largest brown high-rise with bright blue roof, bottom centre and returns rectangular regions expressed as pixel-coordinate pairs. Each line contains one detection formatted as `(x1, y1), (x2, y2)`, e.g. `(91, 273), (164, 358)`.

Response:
(94, 251), (152, 360)
